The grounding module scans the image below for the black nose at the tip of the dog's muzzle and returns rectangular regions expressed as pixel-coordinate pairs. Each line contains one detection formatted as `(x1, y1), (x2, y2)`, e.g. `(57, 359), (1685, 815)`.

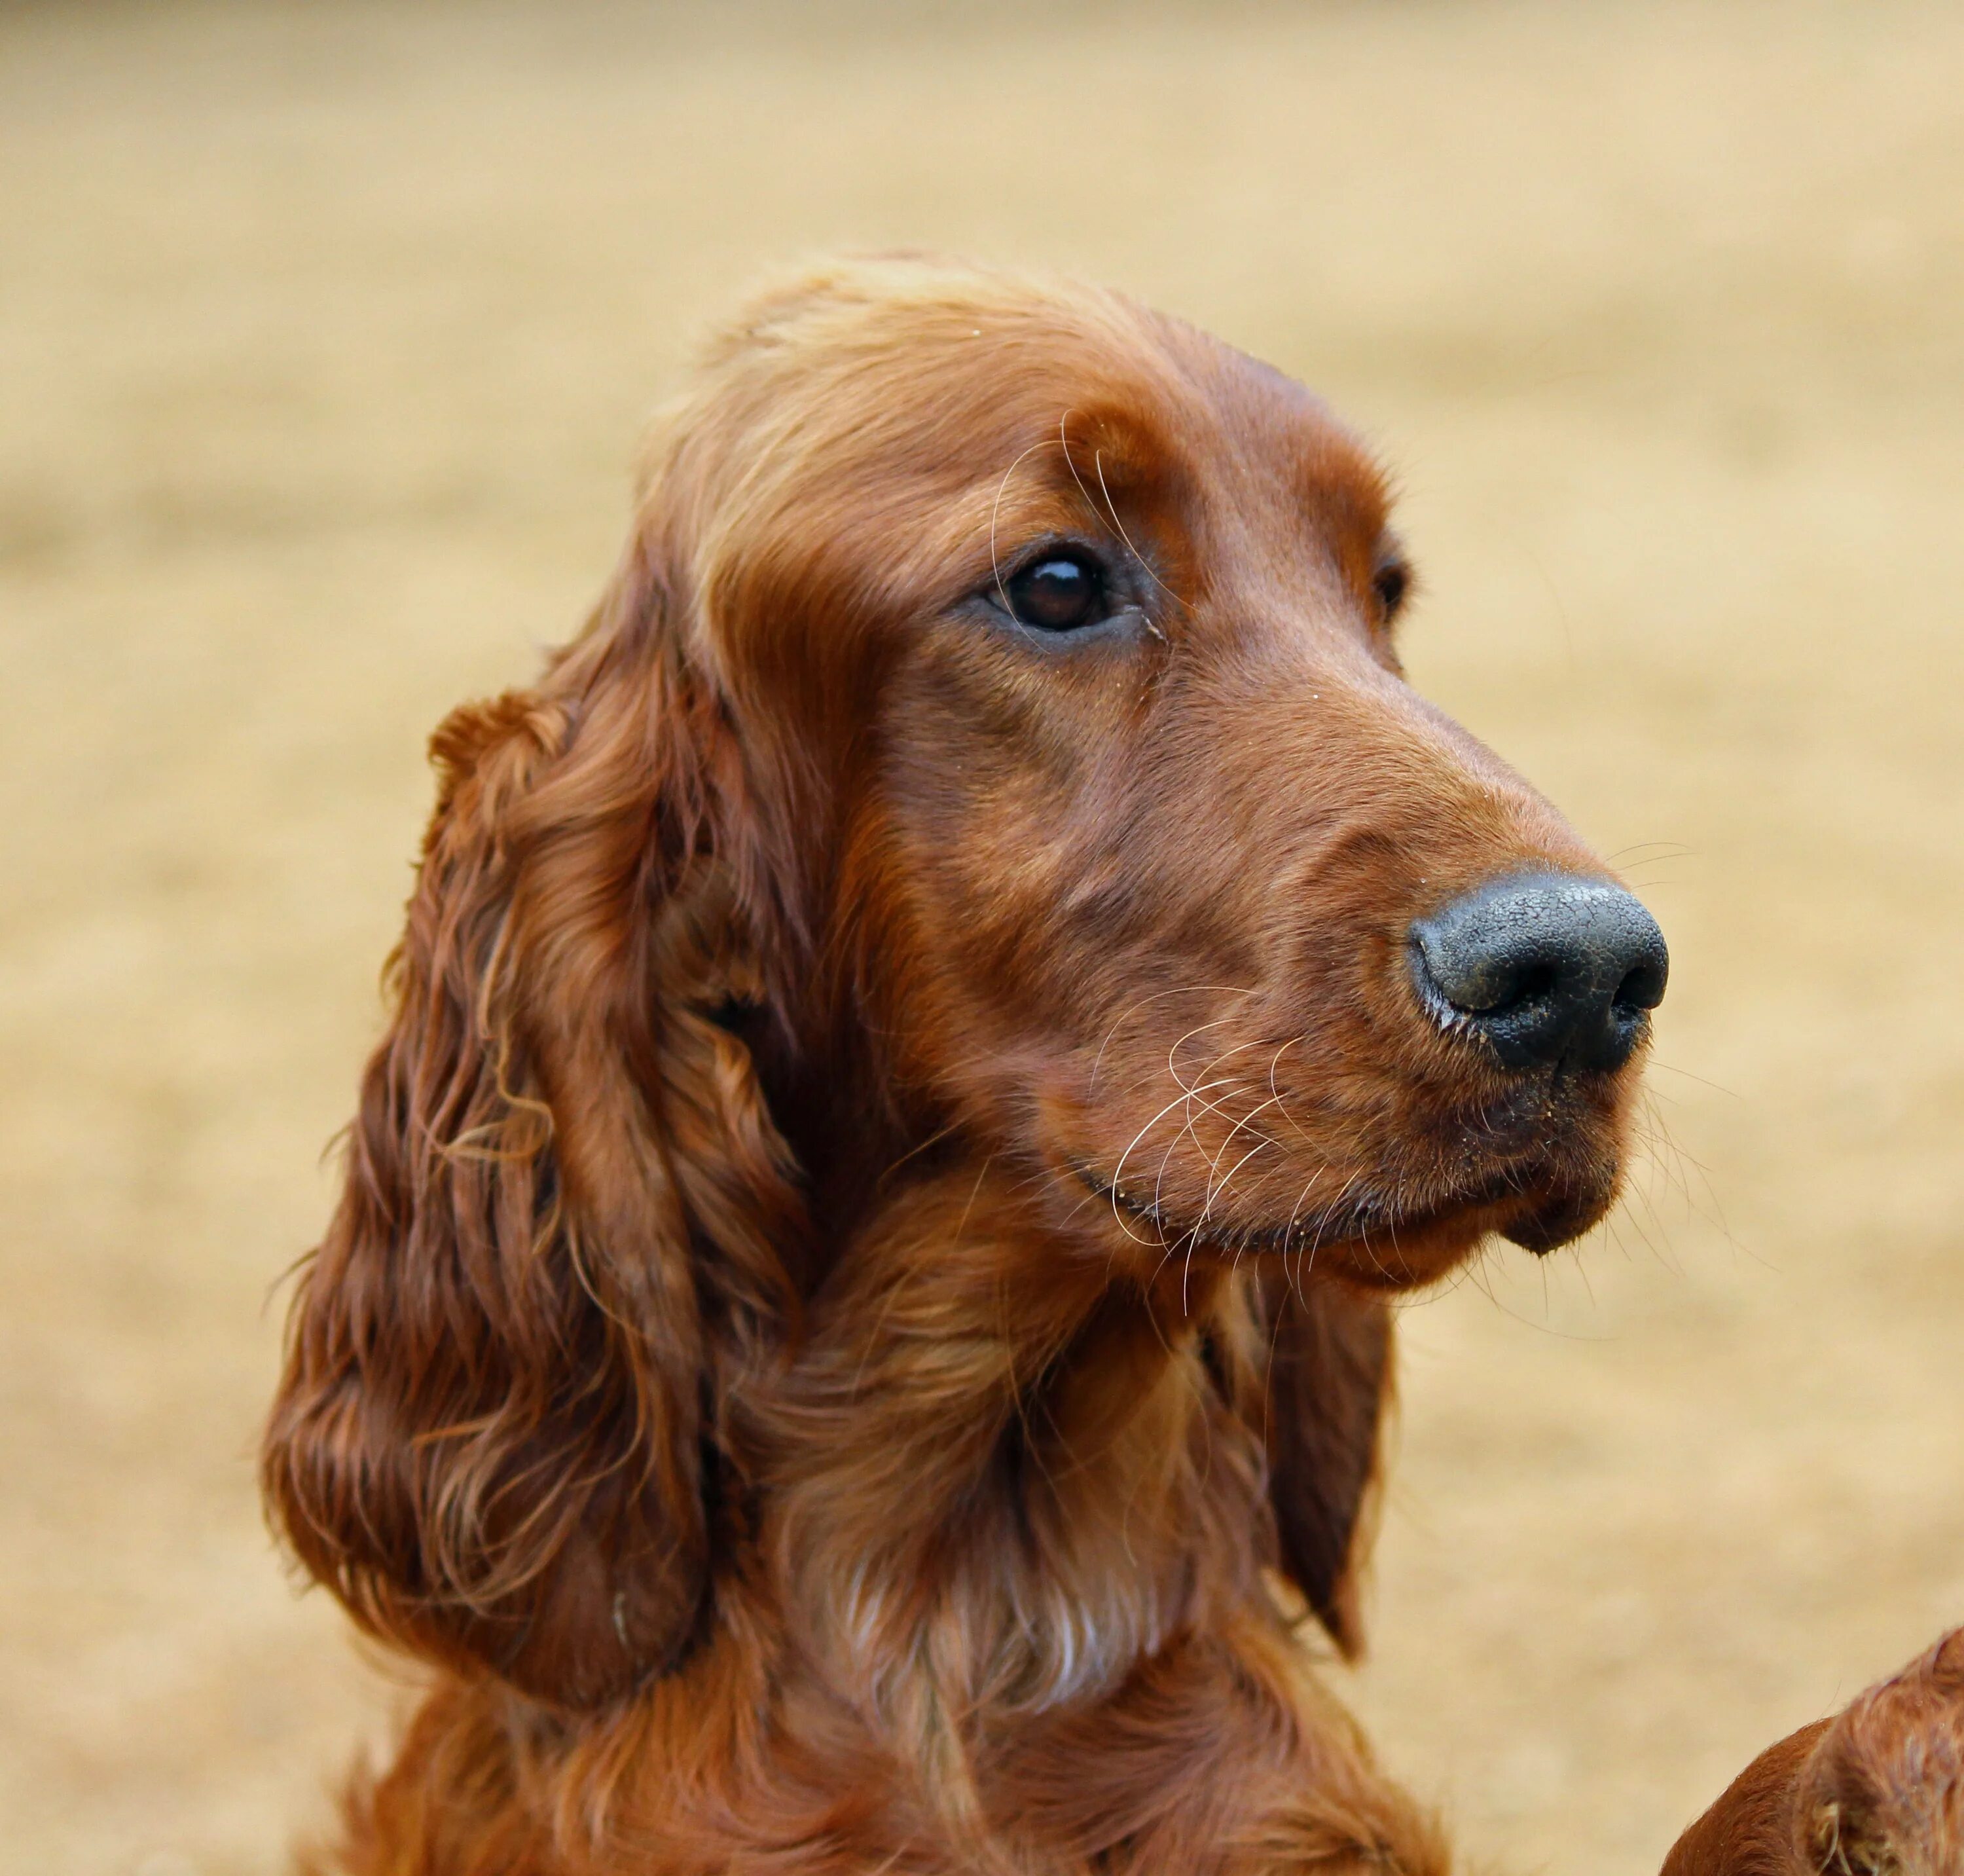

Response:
(1412, 874), (1671, 1071)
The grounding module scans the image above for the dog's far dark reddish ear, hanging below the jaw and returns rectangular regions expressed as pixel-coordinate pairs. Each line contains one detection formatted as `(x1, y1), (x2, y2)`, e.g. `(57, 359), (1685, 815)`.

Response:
(1259, 1267), (1391, 1660)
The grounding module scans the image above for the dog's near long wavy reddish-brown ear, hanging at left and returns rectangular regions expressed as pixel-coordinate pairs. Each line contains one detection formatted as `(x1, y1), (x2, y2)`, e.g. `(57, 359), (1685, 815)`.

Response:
(263, 556), (801, 1707)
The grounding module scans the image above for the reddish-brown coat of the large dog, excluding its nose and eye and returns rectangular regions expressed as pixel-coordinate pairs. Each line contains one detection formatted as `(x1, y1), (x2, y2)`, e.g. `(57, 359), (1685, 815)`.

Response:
(265, 259), (1964, 1876)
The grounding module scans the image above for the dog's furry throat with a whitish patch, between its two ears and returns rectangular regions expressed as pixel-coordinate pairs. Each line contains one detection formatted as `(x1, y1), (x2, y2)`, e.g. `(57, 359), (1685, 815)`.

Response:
(766, 1165), (1261, 1729)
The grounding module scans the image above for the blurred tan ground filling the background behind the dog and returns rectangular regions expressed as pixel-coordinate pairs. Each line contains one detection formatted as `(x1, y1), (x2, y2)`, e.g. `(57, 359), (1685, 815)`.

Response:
(0, 0), (1964, 1876)
